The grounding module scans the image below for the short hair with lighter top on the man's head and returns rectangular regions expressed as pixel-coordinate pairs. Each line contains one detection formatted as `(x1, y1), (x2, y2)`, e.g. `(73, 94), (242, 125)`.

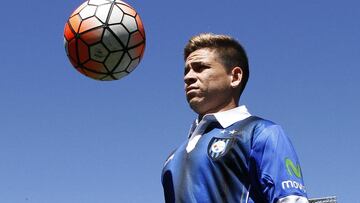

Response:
(184, 33), (249, 95)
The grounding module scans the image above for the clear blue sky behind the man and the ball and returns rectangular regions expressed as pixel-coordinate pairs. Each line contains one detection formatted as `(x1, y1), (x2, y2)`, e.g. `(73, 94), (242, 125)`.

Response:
(0, 0), (360, 203)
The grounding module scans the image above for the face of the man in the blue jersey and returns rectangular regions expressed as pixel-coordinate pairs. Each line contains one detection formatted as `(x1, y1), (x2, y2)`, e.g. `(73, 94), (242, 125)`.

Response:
(184, 49), (234, 116)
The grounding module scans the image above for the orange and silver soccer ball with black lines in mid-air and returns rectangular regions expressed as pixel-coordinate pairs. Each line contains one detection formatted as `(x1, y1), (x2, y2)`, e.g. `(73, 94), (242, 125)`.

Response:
(64, 0), (145, 80)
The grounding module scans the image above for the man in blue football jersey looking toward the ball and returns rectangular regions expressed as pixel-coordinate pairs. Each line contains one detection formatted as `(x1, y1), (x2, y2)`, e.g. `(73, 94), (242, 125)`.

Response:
(162, 34), (308, 203)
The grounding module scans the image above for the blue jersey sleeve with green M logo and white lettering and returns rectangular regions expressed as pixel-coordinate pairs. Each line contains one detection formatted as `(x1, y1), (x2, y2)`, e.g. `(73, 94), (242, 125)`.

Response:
(250, 125), (307, 203)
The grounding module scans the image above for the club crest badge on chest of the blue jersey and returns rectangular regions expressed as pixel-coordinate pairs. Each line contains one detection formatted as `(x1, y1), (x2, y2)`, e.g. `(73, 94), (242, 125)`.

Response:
(208, 137), (234, 160)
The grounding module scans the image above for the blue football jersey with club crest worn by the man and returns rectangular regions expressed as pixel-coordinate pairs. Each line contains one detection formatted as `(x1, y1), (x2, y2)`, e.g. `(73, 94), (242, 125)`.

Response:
(162, 116), (307, 203)
